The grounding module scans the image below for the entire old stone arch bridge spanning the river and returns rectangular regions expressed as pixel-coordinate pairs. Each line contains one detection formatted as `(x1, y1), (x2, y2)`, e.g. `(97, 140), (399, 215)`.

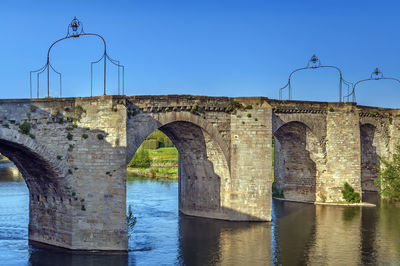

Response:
(0, 95), (400, 251)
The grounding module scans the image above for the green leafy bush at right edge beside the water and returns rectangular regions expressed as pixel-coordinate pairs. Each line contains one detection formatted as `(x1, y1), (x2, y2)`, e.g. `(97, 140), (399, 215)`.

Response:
(374, 144), (400, 201)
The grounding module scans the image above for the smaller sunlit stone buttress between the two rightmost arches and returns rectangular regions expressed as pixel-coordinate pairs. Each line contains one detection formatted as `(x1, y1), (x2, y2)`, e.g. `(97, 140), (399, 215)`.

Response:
(324, 103), (361, 202)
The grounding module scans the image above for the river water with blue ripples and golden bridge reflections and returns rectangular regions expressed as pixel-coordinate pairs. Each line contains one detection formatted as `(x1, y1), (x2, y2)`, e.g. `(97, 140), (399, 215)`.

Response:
(0, 171), (400, 266)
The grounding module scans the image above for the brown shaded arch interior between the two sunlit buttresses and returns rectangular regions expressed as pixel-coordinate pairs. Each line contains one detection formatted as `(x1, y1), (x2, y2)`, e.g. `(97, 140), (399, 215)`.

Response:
(274, 122), (319, 201)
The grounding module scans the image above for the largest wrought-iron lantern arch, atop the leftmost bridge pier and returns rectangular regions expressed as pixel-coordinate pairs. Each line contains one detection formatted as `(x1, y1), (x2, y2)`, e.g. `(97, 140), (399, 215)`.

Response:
(30, 17), (125, 98)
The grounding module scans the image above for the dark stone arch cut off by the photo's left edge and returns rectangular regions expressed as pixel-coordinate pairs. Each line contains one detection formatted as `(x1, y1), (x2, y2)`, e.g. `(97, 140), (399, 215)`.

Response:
(0, 127), (72, 246)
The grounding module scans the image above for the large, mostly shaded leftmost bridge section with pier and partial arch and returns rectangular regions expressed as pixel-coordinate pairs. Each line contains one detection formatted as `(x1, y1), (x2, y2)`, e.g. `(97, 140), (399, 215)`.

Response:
(0, 97), (127, 251)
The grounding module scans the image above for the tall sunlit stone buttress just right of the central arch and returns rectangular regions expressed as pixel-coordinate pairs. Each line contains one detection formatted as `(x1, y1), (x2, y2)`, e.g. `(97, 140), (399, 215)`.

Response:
(224, 98), (272, 221)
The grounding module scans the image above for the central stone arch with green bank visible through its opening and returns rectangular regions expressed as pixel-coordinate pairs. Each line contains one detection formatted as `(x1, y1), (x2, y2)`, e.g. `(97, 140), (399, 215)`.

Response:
(127, 112), (230, 219)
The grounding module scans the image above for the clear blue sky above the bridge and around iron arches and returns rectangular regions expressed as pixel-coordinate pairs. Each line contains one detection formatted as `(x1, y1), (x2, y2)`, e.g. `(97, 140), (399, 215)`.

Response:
(0, 0), (400, 107)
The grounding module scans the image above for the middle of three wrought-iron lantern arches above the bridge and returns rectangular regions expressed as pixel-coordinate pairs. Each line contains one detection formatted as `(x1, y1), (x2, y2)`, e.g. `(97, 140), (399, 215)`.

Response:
(279, 54), (351, 102)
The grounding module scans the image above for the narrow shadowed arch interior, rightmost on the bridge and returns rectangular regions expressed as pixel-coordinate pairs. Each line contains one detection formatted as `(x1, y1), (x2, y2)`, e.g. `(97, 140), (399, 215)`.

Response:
(360, 124), (379, 191)
